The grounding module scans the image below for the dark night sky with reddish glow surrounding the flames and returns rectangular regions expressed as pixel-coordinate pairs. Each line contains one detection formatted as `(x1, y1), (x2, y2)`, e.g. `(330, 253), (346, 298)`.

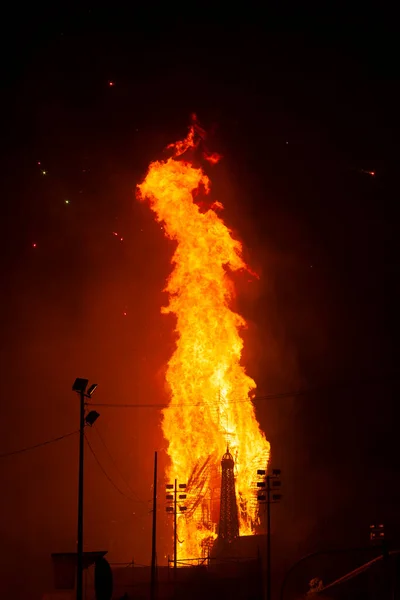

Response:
(0, 7), (400, 598)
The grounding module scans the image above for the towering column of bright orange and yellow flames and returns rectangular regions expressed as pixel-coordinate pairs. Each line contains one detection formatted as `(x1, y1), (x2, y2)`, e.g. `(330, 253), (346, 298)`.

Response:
(138, 123), (270, 559)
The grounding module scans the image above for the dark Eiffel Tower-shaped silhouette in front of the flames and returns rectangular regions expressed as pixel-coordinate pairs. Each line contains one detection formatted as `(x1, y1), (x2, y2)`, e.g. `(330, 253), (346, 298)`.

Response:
(218, 448), (239, 543)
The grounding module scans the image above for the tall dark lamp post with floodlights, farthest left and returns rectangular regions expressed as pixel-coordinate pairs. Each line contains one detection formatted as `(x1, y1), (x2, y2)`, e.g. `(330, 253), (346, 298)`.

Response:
(72, 377), (100, 600)
